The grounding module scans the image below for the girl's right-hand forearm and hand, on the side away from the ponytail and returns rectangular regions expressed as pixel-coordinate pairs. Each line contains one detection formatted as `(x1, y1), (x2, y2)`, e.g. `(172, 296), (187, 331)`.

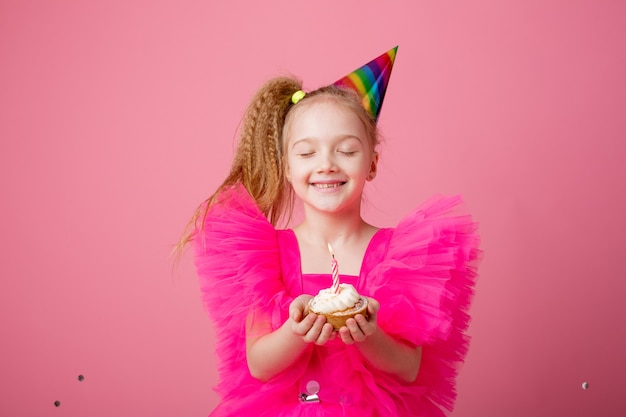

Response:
(339, 298), (422, 382)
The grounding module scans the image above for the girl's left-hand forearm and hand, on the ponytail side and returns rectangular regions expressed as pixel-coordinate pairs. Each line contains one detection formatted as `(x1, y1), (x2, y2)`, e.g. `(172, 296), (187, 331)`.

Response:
(246, 295), (334, 381)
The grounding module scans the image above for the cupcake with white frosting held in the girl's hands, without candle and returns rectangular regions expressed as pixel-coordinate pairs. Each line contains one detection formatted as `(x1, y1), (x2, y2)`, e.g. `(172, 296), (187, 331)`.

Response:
(309, 284), (367, 330)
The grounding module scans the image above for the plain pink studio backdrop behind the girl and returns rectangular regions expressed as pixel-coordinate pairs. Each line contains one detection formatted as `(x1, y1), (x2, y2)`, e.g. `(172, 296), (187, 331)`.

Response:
(0, 0), (626, 417)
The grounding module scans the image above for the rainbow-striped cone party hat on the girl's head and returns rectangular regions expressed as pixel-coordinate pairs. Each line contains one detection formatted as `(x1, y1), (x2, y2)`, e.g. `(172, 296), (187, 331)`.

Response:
(333, 46), (398, 120)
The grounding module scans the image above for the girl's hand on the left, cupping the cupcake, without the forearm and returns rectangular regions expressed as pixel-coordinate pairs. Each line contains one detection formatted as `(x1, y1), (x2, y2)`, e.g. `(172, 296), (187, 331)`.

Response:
(289, 294), (335, 345)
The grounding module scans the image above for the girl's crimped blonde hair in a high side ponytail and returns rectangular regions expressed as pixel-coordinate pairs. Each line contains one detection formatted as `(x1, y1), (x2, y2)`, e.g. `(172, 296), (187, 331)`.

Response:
(173, 77), (378, 253)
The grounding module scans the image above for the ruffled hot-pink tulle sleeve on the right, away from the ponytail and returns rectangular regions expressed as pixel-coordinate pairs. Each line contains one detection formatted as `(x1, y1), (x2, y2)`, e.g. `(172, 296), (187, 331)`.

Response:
(367, 196), (480, 415)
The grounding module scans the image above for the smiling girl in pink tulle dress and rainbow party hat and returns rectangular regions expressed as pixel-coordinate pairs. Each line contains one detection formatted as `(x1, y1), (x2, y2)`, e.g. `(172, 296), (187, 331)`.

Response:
(182, 48), (478, 417)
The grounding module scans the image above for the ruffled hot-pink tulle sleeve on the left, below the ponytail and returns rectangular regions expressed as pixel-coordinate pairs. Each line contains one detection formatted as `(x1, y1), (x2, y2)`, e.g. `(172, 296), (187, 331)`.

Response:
(194, 186), (284, 398)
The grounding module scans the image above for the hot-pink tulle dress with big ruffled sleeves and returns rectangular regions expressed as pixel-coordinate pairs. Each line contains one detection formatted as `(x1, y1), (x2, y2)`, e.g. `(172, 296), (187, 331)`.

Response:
(194, 186), (478, 417)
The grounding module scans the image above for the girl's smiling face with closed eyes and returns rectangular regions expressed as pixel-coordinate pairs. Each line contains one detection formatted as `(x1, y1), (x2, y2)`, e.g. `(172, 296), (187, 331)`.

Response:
(285, 98), (378, 214)
